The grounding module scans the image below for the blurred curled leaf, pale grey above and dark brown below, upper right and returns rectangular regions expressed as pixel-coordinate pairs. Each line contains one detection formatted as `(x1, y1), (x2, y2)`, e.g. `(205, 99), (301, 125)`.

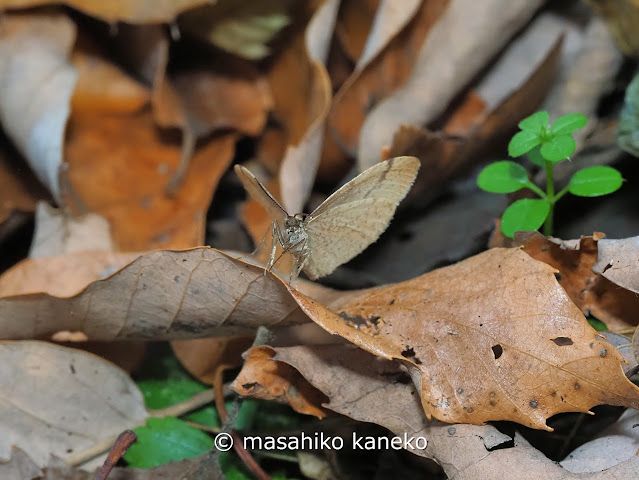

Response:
(388, 14), (564, 205)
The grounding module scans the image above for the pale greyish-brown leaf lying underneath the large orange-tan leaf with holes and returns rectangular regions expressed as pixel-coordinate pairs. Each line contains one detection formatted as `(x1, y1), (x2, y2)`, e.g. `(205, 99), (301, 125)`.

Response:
(251, 345), (639, 480)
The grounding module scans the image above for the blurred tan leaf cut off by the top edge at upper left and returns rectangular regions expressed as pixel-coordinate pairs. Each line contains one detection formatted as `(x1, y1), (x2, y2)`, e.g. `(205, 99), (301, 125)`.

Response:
(1, 0), (209, 23)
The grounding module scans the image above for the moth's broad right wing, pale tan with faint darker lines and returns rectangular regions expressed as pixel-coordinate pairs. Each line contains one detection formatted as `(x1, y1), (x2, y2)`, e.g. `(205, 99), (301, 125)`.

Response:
(304, 157), (420, 280)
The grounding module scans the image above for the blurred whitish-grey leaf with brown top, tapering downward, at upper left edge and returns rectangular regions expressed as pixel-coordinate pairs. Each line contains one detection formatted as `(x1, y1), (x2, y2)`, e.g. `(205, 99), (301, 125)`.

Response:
(0, 11), (77, 202)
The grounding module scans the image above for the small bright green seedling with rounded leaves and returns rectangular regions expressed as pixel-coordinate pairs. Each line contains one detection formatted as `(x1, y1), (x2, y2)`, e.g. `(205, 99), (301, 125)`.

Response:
(477, 111), (623, 238)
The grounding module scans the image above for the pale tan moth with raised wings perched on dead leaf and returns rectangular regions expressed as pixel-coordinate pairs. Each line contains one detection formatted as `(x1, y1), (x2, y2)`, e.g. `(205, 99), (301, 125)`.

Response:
(235, 157), (420, 282)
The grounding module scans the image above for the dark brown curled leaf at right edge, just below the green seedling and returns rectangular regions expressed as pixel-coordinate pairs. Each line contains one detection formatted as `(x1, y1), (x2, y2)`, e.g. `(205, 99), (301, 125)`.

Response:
(515, 232), (639, 330)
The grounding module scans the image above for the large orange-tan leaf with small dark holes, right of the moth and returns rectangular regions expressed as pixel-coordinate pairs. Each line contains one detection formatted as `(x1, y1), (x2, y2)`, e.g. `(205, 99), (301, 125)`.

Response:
(290, 249), (639, 429)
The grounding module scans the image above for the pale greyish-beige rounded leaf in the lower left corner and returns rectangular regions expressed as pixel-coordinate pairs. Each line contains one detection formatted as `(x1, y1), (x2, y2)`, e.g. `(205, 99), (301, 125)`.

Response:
(0, 341), (148, 467)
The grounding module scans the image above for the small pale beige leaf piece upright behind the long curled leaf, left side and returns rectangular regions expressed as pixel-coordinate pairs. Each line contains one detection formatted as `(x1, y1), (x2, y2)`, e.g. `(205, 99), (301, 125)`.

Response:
(29, 202), (113, 258)
